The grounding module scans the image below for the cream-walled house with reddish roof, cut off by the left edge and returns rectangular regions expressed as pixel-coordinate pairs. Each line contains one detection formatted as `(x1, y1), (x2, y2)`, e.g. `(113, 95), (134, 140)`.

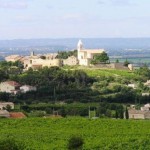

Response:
(0, 81), (21, 94)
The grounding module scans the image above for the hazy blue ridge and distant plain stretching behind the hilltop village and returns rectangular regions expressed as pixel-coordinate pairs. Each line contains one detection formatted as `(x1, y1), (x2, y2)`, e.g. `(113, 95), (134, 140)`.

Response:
(0, 38), (150, 58)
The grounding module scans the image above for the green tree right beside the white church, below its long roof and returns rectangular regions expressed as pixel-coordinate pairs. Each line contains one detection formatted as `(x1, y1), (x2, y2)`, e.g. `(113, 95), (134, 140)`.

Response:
(91, 52), (109, 64)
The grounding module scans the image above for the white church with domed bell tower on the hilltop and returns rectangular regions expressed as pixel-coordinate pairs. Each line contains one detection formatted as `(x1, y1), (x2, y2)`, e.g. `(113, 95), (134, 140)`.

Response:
(77, 40), (105, 66)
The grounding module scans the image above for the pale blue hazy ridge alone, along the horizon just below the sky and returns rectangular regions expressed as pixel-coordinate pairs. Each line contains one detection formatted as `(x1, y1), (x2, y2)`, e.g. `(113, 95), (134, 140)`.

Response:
(0, 38), (150, 49)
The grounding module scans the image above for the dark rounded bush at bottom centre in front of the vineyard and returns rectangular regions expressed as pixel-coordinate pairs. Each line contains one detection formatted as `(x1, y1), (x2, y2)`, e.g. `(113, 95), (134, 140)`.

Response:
(68, 135), (84, 150)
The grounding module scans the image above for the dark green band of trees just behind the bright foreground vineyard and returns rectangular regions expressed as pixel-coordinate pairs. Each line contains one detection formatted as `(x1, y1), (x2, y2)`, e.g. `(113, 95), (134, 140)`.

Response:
(21, 102), (125, 119)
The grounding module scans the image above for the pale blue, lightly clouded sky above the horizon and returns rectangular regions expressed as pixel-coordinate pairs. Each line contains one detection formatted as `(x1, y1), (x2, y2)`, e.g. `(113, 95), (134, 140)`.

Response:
(0, 0), (150, 40)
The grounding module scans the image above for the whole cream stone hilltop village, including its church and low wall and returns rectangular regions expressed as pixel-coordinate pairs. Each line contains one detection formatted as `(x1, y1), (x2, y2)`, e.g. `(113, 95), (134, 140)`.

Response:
(5, 40), (133, 71)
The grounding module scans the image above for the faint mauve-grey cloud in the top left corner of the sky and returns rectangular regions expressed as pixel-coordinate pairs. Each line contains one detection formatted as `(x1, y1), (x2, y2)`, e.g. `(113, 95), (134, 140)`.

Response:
(0, 0), (28, 9)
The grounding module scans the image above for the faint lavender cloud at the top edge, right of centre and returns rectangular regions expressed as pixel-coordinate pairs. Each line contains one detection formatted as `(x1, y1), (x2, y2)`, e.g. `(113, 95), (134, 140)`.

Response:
(98, 0), (135, 6)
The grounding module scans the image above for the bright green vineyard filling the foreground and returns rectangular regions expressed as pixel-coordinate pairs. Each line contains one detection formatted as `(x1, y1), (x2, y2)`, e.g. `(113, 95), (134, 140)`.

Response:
(0, 117), (150, 150)
